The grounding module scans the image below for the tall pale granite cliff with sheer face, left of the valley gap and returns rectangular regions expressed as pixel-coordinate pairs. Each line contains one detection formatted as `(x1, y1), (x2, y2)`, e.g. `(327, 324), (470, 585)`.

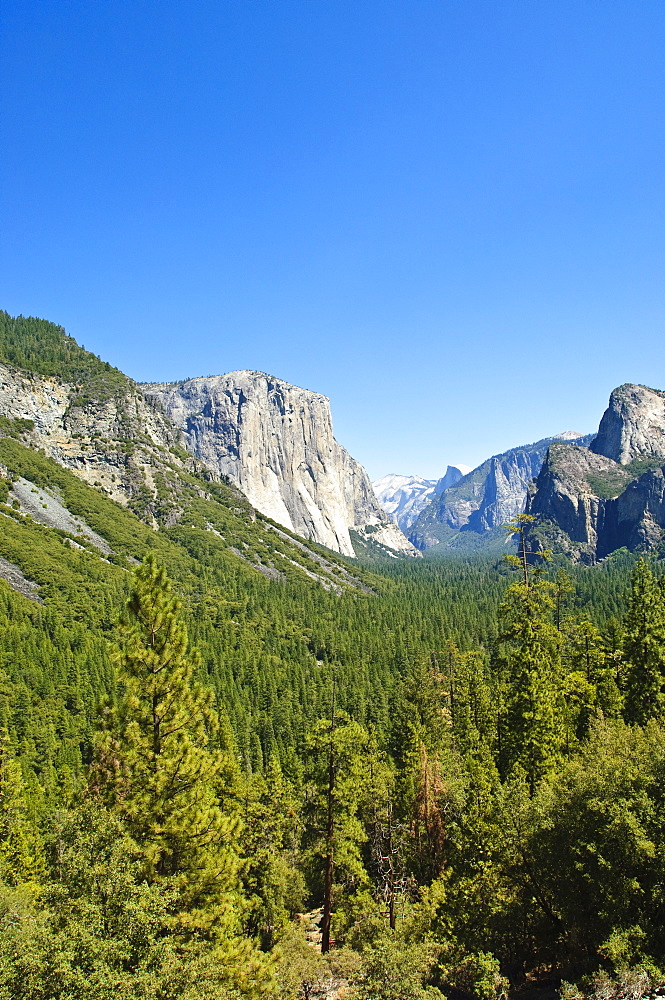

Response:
(142, 371), (416, 556)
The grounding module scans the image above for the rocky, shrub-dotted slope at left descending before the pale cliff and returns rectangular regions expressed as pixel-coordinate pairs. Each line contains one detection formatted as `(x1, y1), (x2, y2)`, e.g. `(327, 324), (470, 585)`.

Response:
(0, 364), (374, 600)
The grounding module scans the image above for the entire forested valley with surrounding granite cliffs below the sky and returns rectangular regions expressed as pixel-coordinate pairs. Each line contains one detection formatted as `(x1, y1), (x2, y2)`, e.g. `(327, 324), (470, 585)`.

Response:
(0, 313), (665, 1000)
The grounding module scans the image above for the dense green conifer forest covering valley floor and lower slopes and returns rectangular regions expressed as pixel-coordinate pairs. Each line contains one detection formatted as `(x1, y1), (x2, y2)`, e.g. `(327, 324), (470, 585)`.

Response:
(0, 314), (665, 1000)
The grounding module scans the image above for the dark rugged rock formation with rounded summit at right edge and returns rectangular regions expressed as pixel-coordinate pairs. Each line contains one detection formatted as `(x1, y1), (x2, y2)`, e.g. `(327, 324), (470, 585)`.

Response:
(526, 385), (665, 563)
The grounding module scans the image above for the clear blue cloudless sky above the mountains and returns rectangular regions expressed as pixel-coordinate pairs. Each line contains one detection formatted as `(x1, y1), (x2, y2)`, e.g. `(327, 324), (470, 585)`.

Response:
(0, 0), (665, 477)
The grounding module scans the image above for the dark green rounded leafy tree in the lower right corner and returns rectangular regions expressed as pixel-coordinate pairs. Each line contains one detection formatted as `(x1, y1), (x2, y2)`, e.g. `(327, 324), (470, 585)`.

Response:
(525, 721), (665, 972)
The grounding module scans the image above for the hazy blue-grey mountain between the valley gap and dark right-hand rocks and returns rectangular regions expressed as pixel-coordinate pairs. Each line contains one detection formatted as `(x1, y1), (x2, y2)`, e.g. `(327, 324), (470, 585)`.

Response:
(408, 431), (592, 551)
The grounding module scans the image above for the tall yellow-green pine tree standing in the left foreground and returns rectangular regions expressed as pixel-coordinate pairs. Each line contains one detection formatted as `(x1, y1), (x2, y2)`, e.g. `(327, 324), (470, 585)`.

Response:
(91, 555), (270, 982)
